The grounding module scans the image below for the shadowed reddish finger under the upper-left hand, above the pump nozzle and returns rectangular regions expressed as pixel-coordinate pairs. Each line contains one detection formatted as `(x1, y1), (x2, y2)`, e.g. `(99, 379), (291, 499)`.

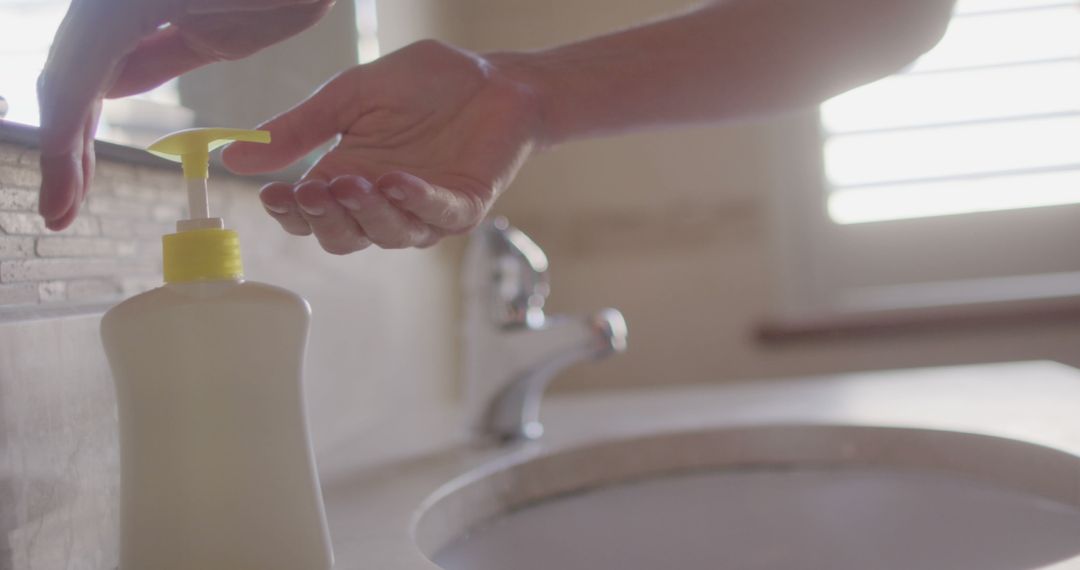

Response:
(106, 26), (216, 97)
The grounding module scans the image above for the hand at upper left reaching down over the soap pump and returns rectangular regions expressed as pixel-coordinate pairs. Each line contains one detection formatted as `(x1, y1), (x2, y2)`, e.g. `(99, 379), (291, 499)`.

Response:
(38, 0), (334, 230)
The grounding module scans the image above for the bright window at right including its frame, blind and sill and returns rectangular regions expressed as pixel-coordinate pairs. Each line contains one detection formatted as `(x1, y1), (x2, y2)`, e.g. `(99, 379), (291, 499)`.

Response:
(778, 0), (1080, 316)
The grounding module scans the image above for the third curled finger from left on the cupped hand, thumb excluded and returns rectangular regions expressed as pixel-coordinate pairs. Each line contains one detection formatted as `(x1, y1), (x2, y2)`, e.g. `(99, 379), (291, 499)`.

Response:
(330, 176), (437, 249)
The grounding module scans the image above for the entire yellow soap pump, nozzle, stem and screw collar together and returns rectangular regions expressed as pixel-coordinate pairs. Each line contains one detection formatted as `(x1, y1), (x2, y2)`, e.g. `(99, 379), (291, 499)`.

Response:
(147, 128), (270, 283)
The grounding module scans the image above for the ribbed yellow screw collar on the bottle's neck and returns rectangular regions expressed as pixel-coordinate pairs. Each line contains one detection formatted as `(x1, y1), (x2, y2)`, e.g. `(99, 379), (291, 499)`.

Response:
(161, 229), (244, 283)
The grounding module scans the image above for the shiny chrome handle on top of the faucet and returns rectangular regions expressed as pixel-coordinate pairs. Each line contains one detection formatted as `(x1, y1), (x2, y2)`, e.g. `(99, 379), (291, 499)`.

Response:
(488, 216), (551, 327)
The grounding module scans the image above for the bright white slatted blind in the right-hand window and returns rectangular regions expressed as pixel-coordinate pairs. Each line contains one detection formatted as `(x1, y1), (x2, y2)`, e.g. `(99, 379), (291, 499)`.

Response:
(821, 0), (1080, 223)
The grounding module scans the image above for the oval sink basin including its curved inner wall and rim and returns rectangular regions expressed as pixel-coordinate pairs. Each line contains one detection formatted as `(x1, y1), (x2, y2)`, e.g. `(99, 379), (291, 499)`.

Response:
(415, 425), (1080, 570)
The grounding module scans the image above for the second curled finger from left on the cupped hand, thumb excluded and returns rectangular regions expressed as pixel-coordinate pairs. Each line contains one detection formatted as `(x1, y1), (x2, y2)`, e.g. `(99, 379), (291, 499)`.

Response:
(295, 176), (372, 255)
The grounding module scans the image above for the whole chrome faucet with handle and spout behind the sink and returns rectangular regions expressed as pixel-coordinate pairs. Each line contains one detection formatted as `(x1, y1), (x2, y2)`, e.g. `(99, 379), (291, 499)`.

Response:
(464, 217), (626, 443)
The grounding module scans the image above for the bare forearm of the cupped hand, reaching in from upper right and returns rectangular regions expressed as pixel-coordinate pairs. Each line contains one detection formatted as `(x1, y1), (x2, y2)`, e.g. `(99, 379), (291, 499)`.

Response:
(490, 0), (953, 145)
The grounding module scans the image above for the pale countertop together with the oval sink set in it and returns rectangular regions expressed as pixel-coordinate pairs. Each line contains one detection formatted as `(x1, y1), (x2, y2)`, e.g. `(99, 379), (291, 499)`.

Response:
(321, 363), (1080, 570)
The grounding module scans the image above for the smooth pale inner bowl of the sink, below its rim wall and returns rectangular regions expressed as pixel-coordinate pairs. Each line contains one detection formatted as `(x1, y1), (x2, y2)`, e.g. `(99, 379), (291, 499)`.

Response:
(434, 469), (1080, 570)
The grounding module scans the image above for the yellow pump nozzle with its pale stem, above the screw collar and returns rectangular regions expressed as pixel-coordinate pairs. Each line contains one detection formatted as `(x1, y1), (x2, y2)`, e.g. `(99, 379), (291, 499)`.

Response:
(147, 128), (270, 230)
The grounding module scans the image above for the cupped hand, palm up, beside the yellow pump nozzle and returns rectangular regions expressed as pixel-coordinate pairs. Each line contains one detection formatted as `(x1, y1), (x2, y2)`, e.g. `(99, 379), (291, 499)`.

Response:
(222, 40), (540, 255)
